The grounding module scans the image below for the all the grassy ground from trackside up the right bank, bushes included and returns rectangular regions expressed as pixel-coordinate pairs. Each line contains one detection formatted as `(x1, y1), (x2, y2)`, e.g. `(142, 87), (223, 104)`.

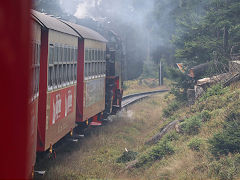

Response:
(36, 83), (240, 180)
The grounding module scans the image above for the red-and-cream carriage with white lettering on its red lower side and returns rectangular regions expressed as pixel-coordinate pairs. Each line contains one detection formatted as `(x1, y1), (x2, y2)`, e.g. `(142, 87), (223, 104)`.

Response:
(32, 11), (78, 151)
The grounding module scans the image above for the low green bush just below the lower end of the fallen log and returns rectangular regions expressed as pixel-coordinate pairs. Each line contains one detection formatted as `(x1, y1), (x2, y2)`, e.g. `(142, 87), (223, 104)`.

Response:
(135, 140), (175, 167)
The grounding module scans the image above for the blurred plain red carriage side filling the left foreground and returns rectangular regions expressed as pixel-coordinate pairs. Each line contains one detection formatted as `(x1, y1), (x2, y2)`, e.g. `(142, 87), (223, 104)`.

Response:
(0, 0), (34, 179)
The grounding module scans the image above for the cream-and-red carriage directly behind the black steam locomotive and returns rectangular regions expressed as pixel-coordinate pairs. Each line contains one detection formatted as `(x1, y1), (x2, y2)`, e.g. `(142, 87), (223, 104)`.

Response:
(64, 21), (106, 125)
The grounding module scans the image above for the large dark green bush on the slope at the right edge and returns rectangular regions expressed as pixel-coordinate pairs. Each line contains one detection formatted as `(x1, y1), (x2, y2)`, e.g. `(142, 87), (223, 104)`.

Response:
(208, 112), (240, 156)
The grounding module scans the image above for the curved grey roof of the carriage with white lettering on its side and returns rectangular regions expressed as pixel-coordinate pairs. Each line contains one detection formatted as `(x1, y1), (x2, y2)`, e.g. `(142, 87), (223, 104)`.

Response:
(31, 10), (79, 37)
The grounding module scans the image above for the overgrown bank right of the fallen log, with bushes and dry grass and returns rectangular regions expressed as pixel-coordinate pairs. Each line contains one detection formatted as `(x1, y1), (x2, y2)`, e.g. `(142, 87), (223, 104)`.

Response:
(137, 83), (240, 179)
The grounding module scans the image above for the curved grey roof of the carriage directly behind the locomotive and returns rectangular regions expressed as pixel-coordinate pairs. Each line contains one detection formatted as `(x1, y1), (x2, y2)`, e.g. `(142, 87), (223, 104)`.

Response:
(61, 20), (108, 42)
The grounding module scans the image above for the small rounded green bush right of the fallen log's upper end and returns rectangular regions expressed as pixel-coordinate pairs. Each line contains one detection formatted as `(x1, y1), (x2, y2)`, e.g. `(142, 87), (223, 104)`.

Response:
(180, 115), (202, 135)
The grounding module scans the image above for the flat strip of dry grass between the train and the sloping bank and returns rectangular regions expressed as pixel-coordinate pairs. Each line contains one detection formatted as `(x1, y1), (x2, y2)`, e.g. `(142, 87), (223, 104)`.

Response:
(36, 94), (168, 179)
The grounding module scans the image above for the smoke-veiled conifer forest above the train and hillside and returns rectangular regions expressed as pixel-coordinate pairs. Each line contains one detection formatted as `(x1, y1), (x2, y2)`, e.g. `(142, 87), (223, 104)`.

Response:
(34, 0), (240, 82)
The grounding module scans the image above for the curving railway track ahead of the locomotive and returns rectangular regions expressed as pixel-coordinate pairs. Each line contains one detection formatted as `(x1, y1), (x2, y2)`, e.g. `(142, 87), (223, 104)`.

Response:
(122, 89), (168, 108)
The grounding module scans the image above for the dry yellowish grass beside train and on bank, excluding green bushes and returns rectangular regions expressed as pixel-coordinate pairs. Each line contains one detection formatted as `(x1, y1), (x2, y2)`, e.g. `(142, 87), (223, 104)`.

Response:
(35, 83), (240, 180)
